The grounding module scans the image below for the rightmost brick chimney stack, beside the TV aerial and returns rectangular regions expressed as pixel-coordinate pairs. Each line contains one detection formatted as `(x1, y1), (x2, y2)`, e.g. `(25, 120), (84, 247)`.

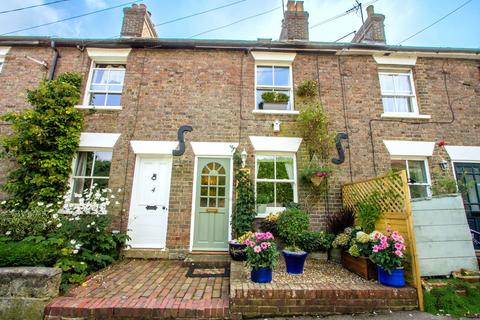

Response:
(352, 5), (386, 44)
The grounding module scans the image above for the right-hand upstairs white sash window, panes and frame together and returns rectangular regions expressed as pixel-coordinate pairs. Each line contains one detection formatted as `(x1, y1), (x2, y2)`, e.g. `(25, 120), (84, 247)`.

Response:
(378, 69), (418, 114)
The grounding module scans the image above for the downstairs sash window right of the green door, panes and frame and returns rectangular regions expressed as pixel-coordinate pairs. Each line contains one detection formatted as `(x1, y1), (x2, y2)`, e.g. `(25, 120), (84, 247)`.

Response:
(255, 154), (298, 216)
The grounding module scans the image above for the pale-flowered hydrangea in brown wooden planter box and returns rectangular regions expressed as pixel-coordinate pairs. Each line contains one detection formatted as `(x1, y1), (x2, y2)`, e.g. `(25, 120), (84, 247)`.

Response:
(342, 228), (377, 280)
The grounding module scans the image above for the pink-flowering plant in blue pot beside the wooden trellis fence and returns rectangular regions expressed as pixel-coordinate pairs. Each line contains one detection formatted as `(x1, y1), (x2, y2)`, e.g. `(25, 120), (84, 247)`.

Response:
(370, 229), (406, 288)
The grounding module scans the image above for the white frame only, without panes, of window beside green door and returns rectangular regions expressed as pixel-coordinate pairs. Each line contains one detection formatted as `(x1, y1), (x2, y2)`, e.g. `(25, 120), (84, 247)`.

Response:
(255, 152), (298, 218)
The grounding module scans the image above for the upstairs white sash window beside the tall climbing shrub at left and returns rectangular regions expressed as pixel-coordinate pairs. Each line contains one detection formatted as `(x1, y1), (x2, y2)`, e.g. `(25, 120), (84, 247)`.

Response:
(85, 61), (125, 109)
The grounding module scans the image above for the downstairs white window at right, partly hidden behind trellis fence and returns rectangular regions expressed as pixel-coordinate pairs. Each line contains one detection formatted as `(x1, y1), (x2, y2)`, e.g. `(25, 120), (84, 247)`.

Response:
(391, 160), (431, 199)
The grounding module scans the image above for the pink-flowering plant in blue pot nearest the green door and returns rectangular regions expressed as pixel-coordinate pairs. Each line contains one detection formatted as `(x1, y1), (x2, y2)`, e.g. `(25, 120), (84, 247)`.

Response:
(245, 232), (278, 283)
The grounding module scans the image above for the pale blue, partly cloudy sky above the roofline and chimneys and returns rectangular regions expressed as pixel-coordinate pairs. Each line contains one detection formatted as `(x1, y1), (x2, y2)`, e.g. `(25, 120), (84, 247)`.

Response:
(0, 0), (480, 48)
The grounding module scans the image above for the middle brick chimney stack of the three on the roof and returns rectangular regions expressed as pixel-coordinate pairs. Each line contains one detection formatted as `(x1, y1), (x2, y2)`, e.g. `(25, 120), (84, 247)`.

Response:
(280, 0), (308, 41)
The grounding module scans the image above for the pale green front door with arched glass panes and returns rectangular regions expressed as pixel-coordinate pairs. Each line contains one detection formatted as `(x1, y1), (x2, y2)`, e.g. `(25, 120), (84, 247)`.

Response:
(193, 158), (230, 250)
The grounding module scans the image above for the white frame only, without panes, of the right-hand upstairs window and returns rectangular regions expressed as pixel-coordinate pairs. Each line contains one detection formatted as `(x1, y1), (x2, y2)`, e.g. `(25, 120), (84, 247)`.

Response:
(378, 68), (418, 118)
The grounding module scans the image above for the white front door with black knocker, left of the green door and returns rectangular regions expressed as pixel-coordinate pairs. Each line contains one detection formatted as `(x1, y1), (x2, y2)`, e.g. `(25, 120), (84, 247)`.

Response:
(128, 156), (172, 249)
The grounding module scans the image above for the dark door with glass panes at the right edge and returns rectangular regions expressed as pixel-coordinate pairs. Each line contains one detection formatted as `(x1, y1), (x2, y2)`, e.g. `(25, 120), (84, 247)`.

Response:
(455, 163), (480, 249)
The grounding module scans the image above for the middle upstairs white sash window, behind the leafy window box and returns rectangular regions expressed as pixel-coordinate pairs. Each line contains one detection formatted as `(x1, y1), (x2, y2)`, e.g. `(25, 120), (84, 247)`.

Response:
(255, 64), (293, 111)
